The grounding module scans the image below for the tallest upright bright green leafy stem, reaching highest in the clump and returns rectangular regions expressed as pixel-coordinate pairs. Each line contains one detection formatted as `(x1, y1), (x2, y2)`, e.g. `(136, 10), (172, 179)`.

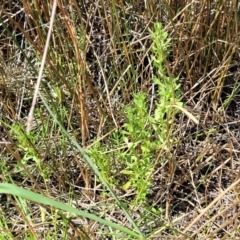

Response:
(150, 23), (183, 149)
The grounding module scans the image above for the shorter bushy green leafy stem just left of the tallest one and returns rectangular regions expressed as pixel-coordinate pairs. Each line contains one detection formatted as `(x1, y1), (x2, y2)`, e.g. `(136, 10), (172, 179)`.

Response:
(121, 93), (158, 201)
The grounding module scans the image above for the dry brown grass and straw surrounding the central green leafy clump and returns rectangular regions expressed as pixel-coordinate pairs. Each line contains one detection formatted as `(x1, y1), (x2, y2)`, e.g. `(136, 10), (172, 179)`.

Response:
(0, 0), (240, 239)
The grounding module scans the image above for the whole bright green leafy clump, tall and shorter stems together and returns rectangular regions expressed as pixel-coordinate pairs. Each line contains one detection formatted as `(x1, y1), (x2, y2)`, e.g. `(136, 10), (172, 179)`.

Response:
(89, 23), (182, 205)
